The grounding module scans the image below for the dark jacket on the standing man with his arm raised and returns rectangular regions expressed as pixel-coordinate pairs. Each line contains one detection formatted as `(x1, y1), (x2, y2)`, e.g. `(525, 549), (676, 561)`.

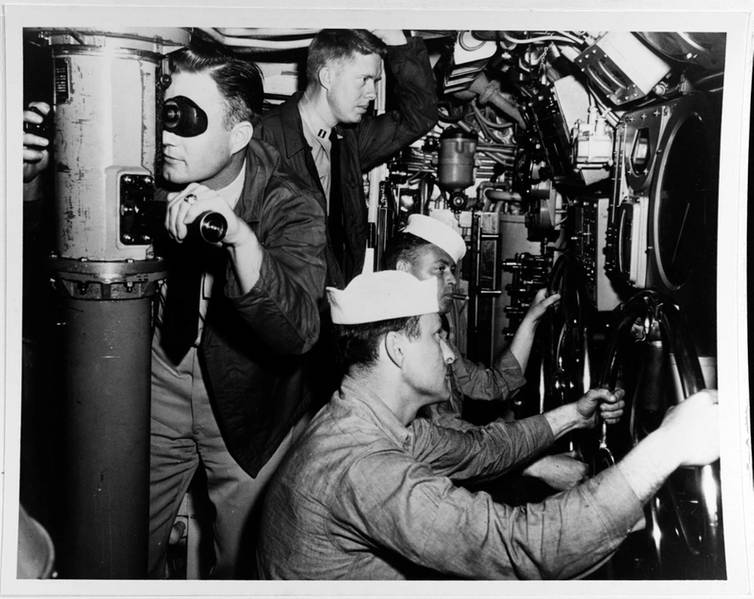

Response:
(254, 38), (437, 287)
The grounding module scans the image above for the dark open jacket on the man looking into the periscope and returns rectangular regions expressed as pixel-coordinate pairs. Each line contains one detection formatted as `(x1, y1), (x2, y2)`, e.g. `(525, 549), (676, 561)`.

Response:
(157, 140), (325, 476)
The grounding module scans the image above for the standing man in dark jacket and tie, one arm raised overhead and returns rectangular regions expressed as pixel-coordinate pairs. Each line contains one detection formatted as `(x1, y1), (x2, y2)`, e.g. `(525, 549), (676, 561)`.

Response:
(255, 29), (437, 412)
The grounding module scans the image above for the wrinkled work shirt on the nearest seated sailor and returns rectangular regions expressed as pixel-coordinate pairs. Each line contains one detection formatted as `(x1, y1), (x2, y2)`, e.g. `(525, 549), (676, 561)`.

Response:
(257, 376), (642, 580)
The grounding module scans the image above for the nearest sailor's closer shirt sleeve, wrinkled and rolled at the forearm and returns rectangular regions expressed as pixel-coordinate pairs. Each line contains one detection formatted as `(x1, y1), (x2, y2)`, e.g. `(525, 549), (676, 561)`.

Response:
(334, 450), (642, 579)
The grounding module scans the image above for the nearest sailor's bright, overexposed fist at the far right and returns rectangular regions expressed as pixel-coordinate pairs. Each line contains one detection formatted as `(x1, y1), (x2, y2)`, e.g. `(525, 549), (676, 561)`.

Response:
(655, 389), (720, 466)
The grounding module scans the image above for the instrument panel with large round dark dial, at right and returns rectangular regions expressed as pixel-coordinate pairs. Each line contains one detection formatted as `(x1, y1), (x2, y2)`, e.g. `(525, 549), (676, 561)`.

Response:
(610, 94), (718, 308)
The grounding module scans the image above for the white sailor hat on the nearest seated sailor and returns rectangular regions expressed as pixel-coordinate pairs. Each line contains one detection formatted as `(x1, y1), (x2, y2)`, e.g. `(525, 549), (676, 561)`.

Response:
(327, 270), (440, 324)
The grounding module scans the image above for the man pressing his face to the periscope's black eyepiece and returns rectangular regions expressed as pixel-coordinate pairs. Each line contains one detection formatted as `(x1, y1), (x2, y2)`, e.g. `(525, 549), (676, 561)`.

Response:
(149, 43), (325, 578)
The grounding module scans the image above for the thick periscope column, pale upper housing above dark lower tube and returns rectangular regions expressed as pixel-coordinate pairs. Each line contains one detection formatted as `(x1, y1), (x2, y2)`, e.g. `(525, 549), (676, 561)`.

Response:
(41, 28), (188, 579)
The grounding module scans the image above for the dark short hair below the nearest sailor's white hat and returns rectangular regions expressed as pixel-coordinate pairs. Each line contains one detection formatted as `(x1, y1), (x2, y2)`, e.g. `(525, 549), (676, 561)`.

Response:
(333, 316), (421, 374)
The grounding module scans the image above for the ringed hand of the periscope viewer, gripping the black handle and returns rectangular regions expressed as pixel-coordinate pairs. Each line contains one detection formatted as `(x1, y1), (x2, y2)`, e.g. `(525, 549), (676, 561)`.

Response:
(165, 183), (245, 245)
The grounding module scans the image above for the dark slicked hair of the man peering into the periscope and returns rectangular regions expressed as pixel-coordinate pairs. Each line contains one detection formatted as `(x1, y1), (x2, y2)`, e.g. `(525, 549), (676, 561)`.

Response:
(169, 41), (264, 128)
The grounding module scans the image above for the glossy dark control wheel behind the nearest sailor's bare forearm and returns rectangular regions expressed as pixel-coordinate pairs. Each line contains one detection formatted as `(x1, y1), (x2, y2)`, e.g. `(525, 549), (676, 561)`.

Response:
(596, 290), (725, 579)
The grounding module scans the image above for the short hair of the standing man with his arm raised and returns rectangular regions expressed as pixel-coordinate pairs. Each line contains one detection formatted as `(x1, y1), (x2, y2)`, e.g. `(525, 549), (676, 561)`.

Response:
(306, 29), (387, 83)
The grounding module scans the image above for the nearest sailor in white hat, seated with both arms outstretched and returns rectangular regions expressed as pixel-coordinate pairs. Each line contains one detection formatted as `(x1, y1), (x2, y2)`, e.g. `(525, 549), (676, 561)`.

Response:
(257, 271), (718, 580)
